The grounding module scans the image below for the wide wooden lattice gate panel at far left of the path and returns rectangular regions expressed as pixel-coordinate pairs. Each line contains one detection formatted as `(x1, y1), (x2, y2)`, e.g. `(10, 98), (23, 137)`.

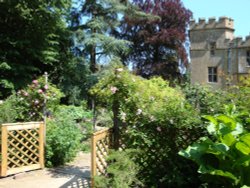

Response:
(0, 122), (44, 176)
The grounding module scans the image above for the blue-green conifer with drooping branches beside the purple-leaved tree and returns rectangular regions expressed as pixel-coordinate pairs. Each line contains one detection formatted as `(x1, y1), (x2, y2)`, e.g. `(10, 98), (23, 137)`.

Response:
(72, 0), (134, 73)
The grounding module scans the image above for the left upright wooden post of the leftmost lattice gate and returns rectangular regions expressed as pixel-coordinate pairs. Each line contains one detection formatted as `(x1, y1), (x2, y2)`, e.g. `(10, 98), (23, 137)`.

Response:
(1, 125), (8, 176)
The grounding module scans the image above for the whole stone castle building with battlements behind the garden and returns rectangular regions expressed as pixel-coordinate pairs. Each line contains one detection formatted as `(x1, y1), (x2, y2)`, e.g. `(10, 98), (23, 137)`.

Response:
(189, 17), (250, 88)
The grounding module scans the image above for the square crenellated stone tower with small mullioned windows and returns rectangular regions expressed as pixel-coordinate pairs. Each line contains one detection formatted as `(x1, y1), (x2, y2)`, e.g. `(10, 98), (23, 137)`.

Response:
(189, 17), (236, 88)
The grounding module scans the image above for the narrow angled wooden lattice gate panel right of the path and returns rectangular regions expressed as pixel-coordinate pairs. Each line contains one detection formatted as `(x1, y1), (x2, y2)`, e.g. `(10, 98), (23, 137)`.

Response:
(91, 128), (113, 187)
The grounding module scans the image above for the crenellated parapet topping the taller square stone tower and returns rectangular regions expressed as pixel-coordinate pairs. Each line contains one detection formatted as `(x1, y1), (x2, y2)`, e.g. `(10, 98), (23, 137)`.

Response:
(189, 17), (234, 31)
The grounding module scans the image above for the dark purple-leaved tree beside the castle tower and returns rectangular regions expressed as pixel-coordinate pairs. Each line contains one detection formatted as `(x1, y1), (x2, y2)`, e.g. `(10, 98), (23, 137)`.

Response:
(121, 0), (191, 79)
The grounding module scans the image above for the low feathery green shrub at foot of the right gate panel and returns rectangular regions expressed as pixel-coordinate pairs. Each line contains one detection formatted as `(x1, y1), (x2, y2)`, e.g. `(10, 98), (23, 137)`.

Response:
(95, 150), (142, 188)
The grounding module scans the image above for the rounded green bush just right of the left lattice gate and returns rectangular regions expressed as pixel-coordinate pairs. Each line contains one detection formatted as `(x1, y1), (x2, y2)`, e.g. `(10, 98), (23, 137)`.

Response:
(46, 106), (82, 167)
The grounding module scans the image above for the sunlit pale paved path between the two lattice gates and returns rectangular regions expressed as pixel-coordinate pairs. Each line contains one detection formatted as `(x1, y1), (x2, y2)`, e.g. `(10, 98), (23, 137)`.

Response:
(0, 153), (90, 188)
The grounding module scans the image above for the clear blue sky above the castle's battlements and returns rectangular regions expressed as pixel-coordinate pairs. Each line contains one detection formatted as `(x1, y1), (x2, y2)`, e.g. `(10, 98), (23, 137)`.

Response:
(182, 0), (250, 37)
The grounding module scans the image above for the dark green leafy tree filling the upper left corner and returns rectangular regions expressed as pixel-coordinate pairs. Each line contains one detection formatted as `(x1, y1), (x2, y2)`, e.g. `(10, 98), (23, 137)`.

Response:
(0, 0), (72, 98)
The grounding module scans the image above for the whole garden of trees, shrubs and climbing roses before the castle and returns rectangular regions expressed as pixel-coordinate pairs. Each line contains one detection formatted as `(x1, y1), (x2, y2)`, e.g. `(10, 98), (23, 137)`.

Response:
(0, 0), (250, 188)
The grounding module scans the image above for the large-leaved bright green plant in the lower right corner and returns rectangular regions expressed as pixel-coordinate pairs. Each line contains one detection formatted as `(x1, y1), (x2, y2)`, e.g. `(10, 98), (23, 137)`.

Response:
(179, 106), (250, 187)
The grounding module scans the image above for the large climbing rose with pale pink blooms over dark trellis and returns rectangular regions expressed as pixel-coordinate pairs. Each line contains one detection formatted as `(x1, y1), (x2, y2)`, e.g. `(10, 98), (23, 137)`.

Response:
(91, 67), (203, 187)
